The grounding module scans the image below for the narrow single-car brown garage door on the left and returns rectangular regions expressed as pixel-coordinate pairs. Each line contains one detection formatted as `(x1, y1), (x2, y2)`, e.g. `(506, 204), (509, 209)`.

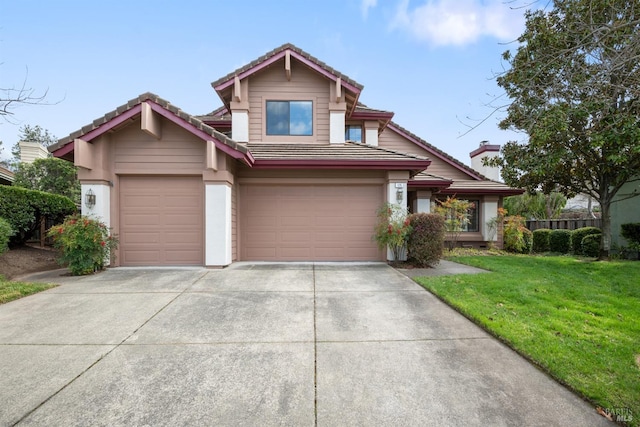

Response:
(120, 177), (204, 265)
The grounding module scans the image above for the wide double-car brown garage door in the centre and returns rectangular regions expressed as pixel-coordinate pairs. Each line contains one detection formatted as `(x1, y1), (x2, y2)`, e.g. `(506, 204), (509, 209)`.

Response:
(240, 185), (383, 261)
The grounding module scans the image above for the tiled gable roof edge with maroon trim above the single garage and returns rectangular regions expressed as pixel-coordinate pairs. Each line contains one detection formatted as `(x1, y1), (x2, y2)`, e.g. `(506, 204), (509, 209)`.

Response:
(48, 92), (247, 153)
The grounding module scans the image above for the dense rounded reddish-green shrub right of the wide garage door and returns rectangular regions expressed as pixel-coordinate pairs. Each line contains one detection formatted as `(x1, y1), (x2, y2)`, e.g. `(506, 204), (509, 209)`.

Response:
(407, 213), (445, 267)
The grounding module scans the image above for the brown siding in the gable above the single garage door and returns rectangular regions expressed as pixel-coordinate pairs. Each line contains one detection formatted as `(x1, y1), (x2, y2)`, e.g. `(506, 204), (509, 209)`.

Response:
(111, 120), (206, 175)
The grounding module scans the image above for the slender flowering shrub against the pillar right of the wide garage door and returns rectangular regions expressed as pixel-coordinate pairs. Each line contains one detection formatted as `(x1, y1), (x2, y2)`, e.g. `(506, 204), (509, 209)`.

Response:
(373, 203), (411, 261)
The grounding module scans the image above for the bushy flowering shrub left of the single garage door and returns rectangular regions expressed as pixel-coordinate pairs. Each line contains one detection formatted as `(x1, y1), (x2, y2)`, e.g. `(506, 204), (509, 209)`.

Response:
(48, 215), (118, 276)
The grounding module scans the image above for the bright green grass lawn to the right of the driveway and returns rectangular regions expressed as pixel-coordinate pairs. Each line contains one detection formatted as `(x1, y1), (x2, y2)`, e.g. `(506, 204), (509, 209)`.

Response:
(417, 256), (640, 426)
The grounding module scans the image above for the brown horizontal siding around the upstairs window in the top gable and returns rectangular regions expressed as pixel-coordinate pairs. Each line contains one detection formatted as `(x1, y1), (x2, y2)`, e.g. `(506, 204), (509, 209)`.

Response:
(249, 60), (329, 144)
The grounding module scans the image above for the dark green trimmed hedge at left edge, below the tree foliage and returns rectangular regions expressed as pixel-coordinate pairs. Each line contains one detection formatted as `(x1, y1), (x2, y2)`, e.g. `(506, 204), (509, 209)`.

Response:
(0, 185), (76, 244)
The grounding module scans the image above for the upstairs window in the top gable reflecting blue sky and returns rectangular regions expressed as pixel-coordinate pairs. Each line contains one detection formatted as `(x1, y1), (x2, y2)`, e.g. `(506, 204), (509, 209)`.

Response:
(267, 101), (313, 136)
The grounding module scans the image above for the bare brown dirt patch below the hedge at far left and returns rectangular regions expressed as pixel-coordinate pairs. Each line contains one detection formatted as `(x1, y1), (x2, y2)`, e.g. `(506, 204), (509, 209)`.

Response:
(0, 246), (60, 279)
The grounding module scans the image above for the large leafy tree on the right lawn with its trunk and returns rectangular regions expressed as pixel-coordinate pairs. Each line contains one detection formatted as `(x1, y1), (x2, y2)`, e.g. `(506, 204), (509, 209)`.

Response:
(493, 0), (640, 258)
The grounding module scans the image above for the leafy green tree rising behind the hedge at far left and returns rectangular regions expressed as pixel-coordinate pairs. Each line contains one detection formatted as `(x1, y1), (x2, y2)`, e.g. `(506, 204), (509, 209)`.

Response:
(13, 157), (80, 203)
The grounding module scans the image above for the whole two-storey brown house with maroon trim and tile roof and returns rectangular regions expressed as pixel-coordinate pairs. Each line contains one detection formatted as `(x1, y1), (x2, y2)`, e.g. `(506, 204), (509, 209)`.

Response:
(49, 44), (520, 266)
